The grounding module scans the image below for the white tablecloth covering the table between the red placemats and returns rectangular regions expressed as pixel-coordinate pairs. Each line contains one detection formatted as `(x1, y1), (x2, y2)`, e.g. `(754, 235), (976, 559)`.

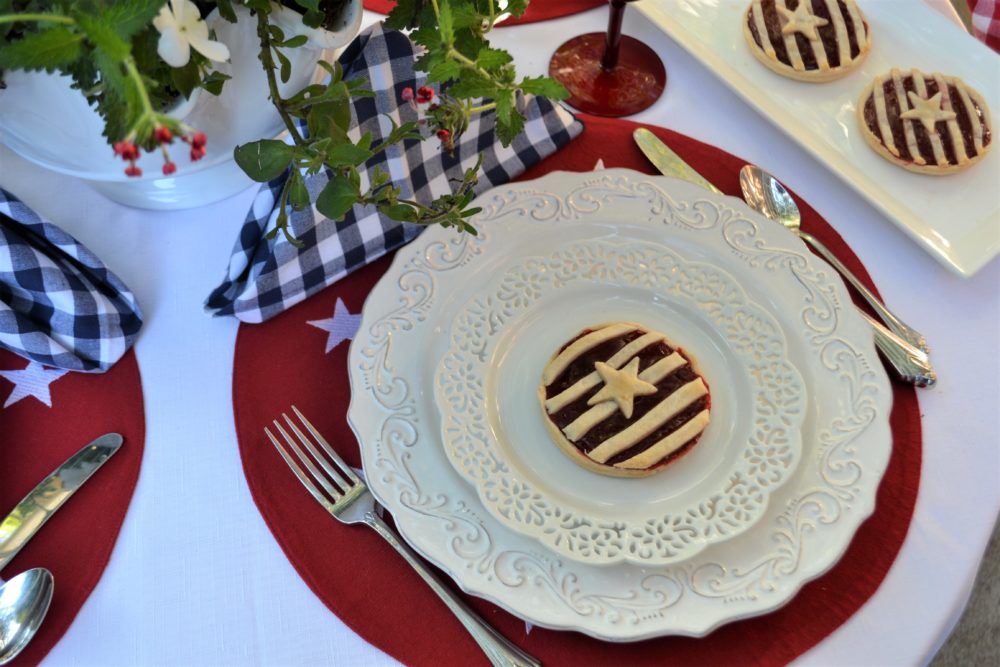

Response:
(0, 5), (1000, 665)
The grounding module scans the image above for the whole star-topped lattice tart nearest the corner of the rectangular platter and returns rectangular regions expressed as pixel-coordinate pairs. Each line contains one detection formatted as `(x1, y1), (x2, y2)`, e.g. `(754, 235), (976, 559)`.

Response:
(858, 69), (993, 176)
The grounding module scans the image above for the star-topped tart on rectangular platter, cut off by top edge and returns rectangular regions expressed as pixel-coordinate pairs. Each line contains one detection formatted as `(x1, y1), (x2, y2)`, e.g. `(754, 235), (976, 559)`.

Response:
(743, 0), (871, 83)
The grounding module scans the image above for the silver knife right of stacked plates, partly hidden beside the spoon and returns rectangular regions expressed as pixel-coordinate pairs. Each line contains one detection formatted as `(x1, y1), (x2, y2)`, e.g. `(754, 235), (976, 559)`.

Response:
(632, 127), (937, 387)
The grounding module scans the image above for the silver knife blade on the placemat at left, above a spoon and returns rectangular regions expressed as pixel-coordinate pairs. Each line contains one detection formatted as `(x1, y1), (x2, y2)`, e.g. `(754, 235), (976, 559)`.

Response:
(0, 433), (123, 571)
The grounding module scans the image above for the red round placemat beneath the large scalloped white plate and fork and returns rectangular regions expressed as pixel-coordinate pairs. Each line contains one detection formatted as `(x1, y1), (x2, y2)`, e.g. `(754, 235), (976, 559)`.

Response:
(233, 116), (921, 666)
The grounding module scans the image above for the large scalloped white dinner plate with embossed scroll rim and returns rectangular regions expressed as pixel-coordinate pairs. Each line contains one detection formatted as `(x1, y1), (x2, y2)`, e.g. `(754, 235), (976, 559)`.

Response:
(348, 169), (892, 641)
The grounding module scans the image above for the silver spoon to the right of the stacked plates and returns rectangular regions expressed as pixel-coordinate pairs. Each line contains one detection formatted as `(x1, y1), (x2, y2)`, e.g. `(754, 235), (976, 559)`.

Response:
(740, 164), (930, 354)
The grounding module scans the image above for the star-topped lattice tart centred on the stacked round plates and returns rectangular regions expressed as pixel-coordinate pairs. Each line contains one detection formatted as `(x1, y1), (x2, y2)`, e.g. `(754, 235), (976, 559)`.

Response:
(538, 322), (711, 477)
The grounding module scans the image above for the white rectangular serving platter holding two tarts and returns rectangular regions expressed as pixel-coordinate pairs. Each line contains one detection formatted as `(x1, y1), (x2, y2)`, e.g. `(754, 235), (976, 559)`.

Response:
(636, 0), (1000, 277)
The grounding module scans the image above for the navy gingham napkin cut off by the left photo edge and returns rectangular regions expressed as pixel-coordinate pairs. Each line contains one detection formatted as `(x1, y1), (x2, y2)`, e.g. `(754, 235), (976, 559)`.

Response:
(0, 189), (142, 373)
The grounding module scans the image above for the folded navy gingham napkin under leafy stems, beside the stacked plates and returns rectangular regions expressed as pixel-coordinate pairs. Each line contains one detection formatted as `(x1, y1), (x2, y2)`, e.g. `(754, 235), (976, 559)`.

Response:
(205, 24), (583, 322)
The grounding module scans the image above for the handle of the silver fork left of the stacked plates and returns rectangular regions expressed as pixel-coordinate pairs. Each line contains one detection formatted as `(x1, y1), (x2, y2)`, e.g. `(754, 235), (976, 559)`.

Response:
(364, 512), (542, 667)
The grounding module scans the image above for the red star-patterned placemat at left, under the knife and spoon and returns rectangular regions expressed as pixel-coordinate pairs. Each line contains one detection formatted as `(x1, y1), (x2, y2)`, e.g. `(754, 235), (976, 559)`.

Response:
(0, 350), (146, 665)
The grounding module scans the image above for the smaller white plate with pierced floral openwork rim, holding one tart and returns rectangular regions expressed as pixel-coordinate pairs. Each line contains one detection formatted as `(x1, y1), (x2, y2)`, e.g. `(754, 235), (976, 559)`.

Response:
(434, 237), (807, 565)
